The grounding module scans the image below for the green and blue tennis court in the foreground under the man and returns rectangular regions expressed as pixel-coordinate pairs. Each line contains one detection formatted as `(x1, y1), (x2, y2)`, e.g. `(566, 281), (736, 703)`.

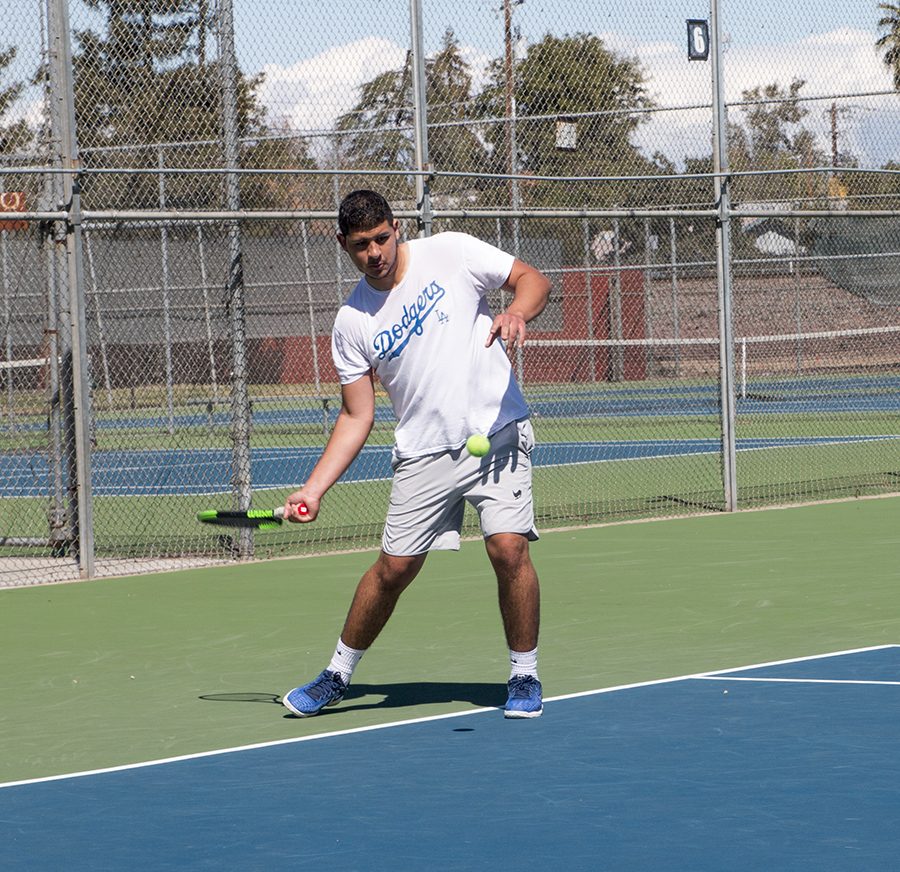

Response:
(0, 497), (900, 870)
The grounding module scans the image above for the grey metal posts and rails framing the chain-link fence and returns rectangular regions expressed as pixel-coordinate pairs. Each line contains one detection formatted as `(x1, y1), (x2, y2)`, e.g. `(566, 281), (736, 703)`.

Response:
(0, 0), (897, 578)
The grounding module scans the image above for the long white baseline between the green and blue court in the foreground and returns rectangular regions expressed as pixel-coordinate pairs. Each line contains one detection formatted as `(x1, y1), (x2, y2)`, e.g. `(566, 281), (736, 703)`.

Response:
(0, 645), (900, 790)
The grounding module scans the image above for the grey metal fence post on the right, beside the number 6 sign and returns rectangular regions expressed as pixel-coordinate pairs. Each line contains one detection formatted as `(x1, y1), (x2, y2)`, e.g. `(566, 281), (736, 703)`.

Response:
(710, 0), (737, 512)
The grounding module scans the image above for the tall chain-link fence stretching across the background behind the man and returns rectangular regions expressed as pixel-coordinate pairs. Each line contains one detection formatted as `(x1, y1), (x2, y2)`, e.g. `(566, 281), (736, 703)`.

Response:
(0, 0), (900, 586)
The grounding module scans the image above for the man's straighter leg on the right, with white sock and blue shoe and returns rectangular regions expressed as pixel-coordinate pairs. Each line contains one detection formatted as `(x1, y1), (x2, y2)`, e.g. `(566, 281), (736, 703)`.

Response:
(485, 533), (544, 718)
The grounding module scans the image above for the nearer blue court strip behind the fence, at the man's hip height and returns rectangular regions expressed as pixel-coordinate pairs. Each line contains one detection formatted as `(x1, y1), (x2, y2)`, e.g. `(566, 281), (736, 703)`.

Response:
(7, 434), (900, 497)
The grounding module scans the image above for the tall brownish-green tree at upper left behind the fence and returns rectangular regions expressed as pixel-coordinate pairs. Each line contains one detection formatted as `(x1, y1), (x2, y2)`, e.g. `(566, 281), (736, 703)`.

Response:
(74, 0), (312, 208)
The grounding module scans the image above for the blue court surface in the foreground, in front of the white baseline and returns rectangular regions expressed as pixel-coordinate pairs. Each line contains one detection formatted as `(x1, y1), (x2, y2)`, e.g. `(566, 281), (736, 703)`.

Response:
(0, 645), (900, 872)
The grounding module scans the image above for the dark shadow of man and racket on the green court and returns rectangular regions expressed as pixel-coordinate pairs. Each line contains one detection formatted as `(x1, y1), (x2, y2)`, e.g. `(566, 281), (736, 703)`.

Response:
(200, 681), (506, 718)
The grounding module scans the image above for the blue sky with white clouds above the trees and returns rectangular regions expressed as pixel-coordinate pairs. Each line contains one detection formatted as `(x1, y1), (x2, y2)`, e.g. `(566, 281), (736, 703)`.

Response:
(0, 0), (900, 166)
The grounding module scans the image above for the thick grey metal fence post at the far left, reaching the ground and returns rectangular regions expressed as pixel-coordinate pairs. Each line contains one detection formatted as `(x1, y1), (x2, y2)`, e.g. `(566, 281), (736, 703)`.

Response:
(48, 0), (94, 578)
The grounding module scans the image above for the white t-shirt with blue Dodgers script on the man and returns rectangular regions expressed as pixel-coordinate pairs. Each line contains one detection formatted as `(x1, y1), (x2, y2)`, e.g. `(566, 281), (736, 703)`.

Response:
(331, 233), (528, 458)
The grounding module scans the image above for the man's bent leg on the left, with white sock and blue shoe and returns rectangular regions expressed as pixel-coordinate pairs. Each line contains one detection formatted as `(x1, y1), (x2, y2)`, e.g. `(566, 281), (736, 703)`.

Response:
(283, 551), (427, 717)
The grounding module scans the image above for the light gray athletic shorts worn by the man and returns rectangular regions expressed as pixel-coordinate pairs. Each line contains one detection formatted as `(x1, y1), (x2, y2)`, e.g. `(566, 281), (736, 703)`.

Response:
(381, 420), (538, 557)
